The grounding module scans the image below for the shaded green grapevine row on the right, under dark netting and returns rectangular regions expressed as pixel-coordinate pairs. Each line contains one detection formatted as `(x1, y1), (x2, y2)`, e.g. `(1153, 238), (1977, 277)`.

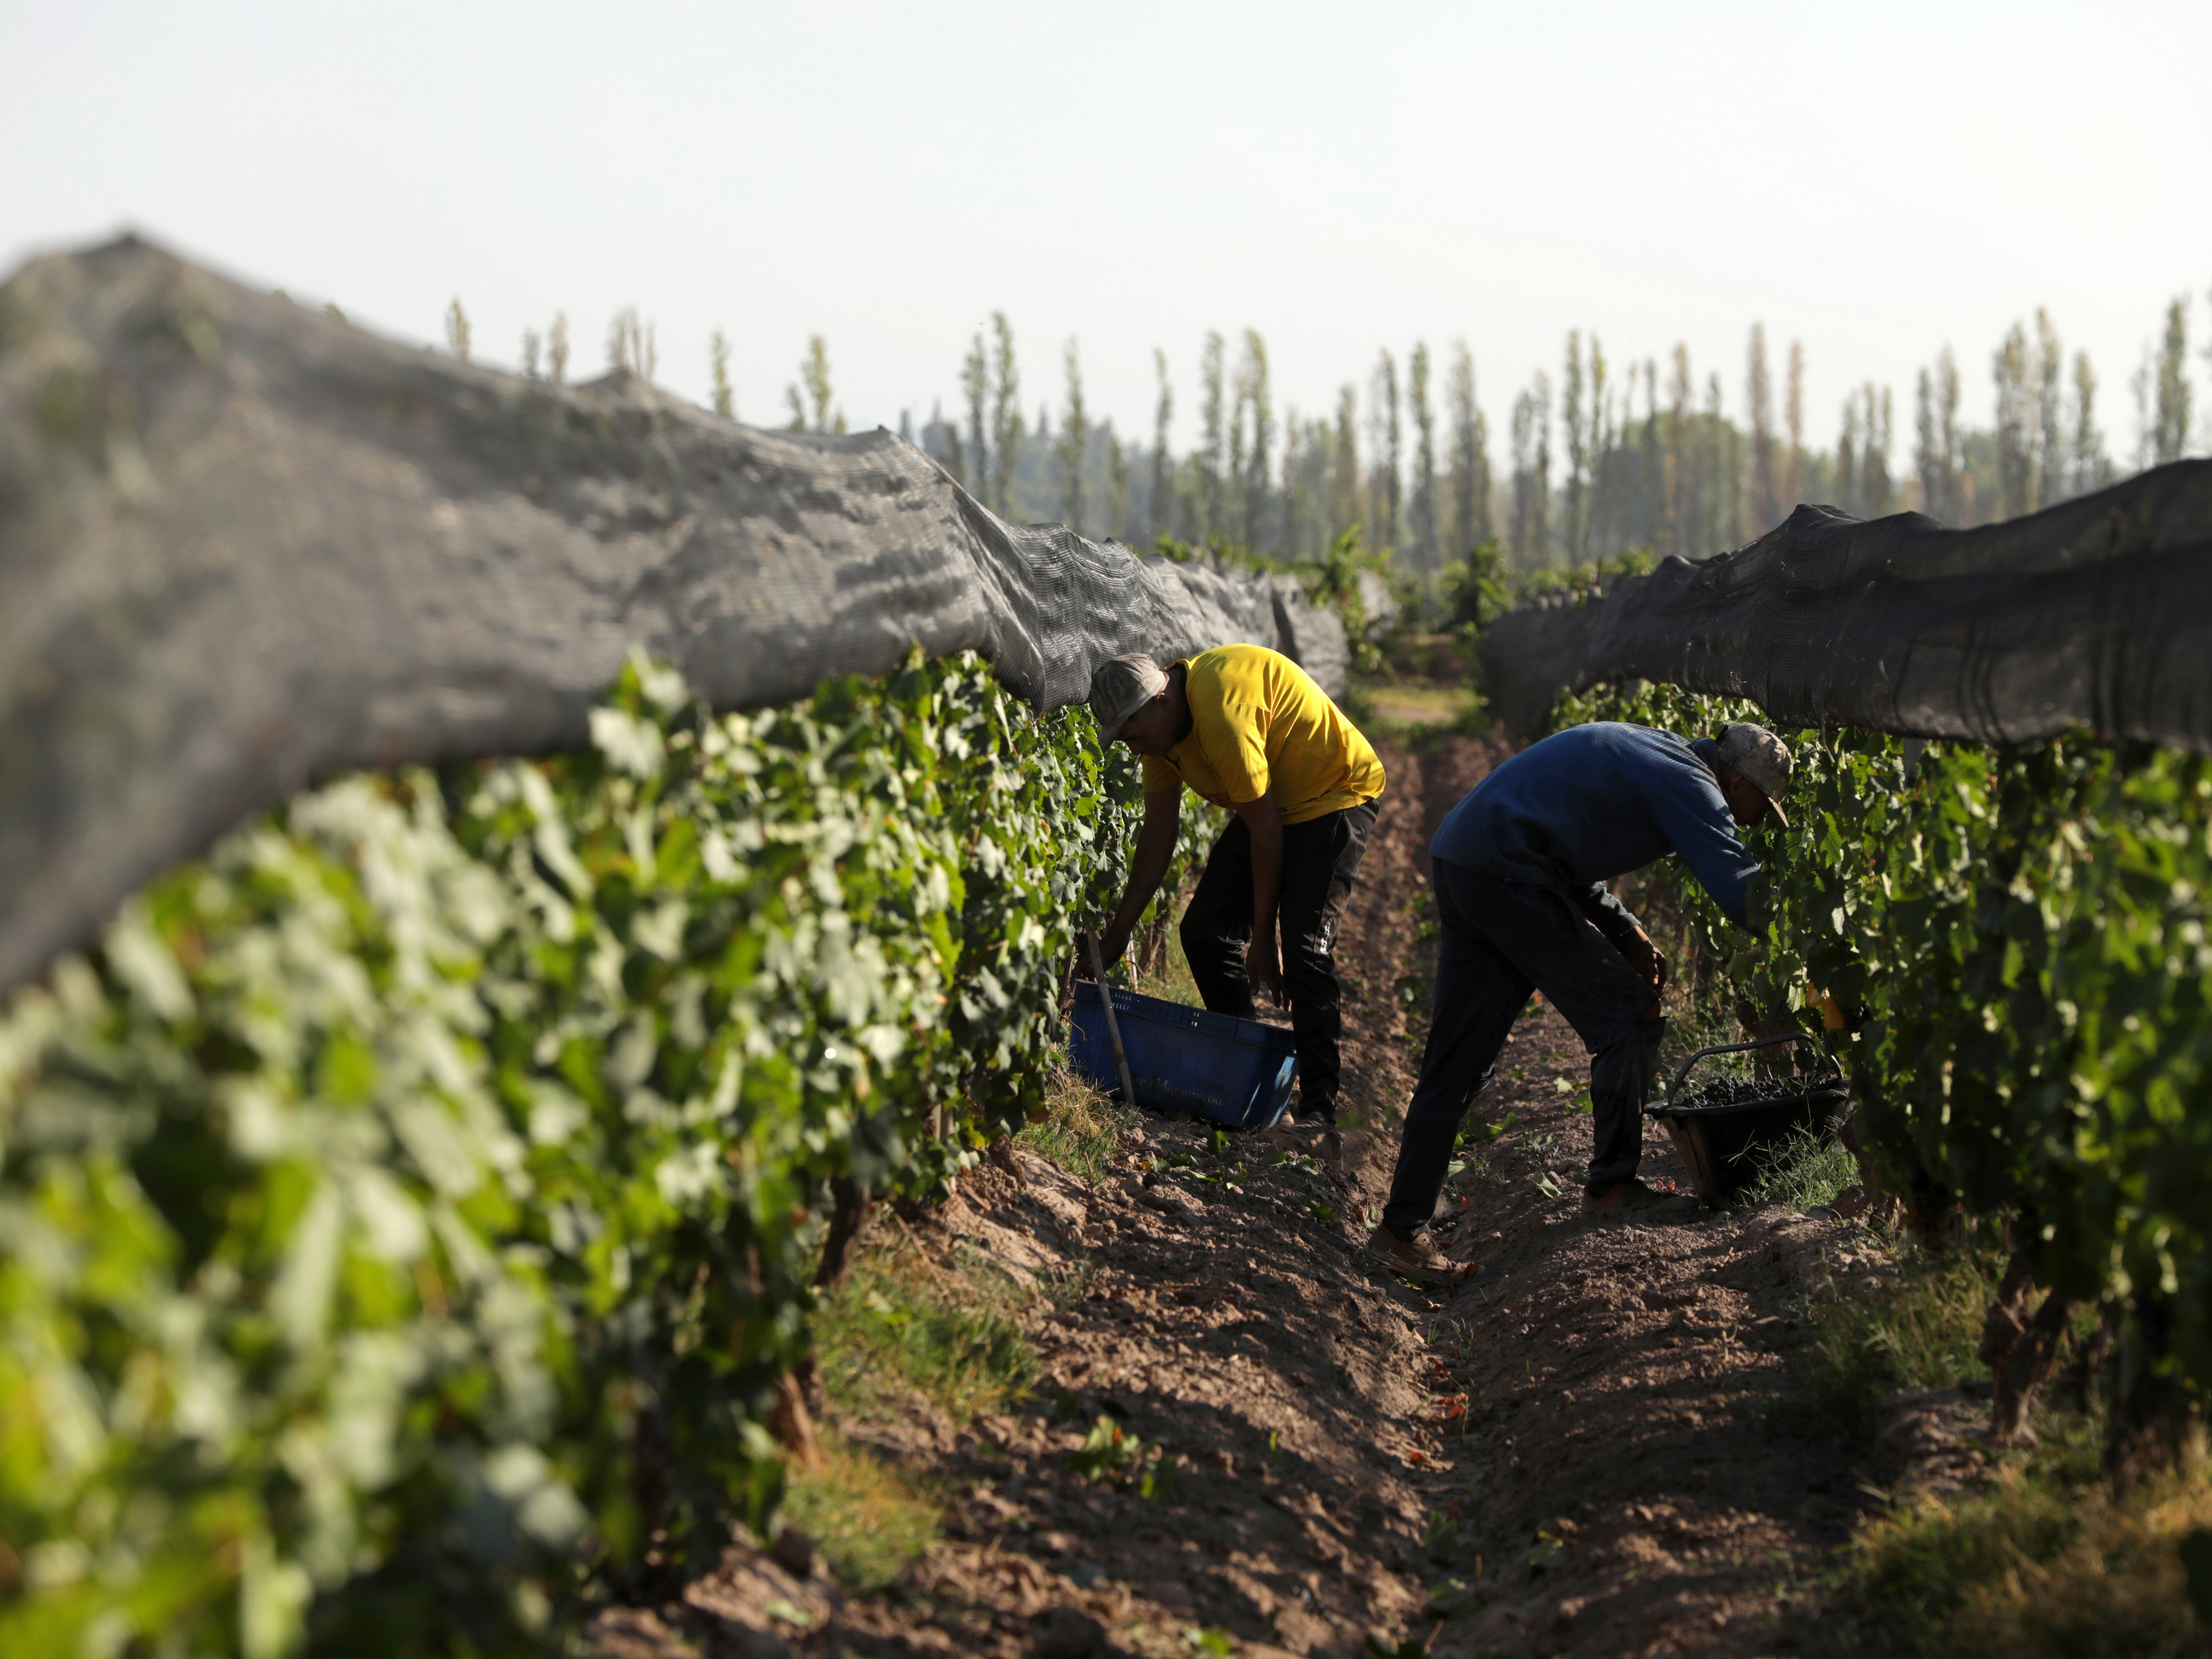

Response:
(1559, 686), (2212, 1424)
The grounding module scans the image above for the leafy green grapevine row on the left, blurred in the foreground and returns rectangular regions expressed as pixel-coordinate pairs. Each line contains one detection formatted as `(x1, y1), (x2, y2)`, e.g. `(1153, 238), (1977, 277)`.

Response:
(0, 657), (1135, 1659)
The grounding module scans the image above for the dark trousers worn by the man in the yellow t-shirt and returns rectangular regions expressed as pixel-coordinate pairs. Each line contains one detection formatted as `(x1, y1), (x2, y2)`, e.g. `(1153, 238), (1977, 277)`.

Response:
(1181, 801), (1376, 1124)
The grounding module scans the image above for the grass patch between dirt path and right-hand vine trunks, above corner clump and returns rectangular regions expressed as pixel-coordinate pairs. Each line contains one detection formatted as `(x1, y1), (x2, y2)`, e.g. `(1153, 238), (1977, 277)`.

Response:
(1796, 1241), (2004, 1440)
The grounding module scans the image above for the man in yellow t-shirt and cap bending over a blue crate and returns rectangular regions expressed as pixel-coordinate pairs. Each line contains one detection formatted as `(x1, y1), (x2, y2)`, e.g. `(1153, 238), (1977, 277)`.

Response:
(1091, 646), (1383, 1130)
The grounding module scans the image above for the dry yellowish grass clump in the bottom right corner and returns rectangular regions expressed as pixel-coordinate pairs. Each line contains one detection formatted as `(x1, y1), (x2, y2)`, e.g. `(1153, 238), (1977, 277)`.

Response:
(1840, 1420), (2212, 1659)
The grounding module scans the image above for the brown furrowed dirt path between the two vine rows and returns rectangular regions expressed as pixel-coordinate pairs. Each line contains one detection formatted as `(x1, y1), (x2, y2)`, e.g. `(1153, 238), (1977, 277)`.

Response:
(597, 741), (1863, 1659)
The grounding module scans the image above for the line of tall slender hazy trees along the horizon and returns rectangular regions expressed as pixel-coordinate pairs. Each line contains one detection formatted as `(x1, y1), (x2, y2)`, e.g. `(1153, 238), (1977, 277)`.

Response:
(447, 281), (2212, 573)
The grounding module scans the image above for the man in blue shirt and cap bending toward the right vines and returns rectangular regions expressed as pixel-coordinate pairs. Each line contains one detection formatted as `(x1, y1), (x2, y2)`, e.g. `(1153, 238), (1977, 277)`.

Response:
(1369, 721), (1789, 1283)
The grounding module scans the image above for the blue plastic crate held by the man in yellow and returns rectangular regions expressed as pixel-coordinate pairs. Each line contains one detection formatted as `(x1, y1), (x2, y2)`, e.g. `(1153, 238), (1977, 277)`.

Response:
(1068, 980), (1299, 1128)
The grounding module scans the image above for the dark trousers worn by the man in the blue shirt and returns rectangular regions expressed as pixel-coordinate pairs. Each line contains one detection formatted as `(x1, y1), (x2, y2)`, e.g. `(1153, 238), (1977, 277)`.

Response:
(1383, 858), (1665, 1239)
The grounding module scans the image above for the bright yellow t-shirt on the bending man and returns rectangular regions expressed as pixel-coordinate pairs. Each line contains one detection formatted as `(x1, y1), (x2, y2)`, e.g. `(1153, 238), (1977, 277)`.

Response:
(1144, 646), (1383, 823)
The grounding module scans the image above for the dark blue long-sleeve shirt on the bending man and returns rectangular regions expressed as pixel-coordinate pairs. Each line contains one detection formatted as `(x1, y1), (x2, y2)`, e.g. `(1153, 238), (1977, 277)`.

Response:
(1429, 721), (1759, 936)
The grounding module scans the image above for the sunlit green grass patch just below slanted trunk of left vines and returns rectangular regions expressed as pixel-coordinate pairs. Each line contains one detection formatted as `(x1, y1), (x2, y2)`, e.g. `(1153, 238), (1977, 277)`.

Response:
(814, 1241), (1037, 1427)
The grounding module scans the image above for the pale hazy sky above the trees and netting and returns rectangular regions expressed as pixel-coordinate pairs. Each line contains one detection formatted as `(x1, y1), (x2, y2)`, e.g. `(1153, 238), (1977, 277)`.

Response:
(0, 0), (2212, 460)
